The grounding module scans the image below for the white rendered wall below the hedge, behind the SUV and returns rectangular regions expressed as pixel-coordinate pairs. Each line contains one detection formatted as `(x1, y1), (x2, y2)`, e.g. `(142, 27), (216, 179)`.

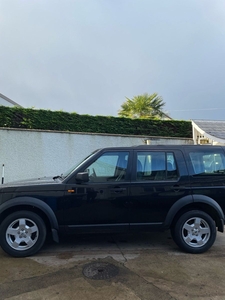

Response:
(0, 128), (193, 183)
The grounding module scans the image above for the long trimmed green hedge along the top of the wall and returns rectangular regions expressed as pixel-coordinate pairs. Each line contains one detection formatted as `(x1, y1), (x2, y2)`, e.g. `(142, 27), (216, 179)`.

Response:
(0, 106), (192, 138)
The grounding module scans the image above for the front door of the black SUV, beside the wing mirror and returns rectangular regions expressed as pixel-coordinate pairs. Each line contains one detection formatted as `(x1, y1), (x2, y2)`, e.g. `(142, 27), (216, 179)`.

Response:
(64, 150), (130, 232)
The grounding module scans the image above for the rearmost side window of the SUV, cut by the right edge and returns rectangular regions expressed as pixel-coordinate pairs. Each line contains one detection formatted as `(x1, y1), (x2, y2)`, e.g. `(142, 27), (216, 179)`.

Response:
(189, 149), (225, 176)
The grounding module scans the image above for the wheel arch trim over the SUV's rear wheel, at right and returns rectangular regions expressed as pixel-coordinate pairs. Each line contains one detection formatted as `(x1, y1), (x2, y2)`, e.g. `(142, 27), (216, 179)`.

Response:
(164, 195), (224, 232)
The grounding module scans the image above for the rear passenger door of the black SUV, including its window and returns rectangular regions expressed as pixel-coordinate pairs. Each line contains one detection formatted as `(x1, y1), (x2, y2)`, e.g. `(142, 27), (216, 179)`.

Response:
(127, 149), (190, 230)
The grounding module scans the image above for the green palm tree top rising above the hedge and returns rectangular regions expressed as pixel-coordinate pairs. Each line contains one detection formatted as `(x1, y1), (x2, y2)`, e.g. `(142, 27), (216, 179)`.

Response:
(118, 93), (165, 119)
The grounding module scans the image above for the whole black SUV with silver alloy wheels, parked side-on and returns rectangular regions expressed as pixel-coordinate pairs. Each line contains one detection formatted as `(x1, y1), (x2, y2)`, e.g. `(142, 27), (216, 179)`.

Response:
(0, 145), (225, 257)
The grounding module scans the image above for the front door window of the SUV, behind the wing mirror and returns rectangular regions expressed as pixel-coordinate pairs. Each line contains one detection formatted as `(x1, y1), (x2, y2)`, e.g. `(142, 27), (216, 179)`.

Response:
(84, 151), (129, 182)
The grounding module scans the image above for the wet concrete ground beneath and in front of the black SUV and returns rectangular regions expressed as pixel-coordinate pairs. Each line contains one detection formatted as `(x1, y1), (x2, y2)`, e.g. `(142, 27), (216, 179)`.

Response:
(0, 232), (225, 300)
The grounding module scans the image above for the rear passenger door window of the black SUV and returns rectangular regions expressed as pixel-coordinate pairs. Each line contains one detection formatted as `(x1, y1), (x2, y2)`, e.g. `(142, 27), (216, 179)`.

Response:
(136, 151), (178, 180)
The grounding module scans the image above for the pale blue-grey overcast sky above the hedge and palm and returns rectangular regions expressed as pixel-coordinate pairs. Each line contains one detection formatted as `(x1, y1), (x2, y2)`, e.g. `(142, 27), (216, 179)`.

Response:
(0, 0), (225, 120)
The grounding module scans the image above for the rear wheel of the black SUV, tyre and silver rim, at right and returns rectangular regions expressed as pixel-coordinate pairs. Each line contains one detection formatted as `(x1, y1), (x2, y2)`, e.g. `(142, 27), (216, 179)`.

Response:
(171, 210), (217, 254)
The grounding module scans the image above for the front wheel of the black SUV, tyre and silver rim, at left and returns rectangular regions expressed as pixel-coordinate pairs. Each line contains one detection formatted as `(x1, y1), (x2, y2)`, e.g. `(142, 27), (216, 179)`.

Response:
(0, 211), (46, 257)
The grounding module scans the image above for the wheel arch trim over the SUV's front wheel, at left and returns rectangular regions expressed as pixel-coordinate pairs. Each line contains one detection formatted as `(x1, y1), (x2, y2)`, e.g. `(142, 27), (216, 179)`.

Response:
(0, 197), (59, 242)
